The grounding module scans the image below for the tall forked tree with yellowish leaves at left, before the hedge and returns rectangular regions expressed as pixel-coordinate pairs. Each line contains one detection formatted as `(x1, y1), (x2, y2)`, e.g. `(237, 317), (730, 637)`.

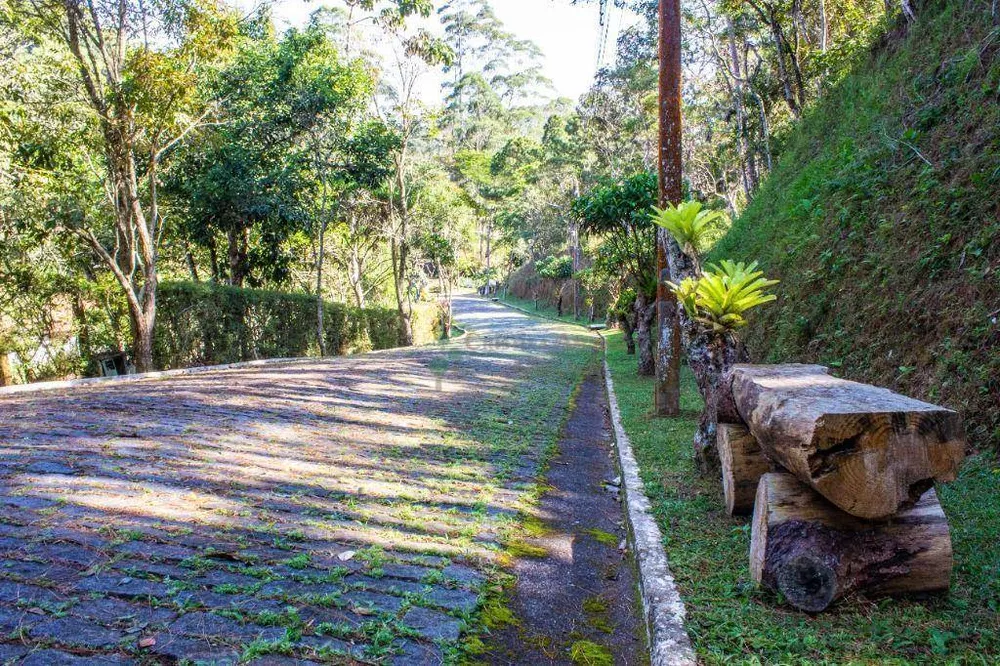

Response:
(13, 0), (238, 372)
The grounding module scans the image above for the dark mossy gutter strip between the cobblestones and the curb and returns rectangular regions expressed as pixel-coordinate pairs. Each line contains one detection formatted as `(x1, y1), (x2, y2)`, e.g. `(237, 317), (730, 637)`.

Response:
(486, 368), (648, 666)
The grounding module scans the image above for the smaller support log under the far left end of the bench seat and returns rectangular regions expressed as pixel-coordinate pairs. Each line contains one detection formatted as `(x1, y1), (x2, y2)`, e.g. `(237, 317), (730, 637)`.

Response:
(718, 423), (773, 516)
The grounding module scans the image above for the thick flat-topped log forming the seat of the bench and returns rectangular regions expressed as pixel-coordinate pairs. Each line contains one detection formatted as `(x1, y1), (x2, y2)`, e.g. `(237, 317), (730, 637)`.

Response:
(728, 365), (965, 519)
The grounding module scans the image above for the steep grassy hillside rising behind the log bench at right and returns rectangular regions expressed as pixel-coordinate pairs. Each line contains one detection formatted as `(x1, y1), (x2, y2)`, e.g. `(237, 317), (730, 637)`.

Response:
(712, 0), (1000, 448)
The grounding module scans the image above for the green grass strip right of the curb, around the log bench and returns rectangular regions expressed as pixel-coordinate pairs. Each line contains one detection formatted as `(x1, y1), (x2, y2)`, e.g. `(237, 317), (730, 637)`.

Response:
(607, 333), (1000, 664)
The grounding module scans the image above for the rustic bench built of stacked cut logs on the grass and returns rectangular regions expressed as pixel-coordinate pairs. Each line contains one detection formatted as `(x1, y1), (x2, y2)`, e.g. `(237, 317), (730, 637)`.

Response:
(719, 365), (965, 612)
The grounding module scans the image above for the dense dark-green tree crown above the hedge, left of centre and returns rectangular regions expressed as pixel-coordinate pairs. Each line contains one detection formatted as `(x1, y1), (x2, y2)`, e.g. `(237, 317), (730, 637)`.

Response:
(168, 24), (376, 286)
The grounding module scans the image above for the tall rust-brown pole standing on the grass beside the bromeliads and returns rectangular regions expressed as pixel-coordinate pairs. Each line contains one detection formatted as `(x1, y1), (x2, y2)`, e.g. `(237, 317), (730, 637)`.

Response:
(655, 0), (682, 416)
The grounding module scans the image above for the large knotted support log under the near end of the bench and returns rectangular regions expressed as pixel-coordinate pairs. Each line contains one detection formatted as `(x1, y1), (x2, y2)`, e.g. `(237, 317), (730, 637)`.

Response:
(750, 472), (952, 613)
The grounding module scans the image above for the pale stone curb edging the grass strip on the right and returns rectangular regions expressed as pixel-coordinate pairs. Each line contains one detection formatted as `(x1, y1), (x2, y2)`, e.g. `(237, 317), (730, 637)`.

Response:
(601, 335), (698, 666)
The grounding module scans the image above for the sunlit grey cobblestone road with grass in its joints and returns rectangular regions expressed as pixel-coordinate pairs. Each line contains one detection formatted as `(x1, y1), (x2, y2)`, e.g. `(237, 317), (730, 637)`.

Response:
(0, 297), (595, 666)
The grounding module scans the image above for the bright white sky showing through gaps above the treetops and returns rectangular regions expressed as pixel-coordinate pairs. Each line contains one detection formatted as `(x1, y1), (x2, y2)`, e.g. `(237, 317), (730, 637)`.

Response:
(250, 0), (634, 101)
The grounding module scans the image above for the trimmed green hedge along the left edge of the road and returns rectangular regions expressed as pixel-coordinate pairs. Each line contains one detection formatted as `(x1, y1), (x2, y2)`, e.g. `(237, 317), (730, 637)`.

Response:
(154, 282), (440, 370)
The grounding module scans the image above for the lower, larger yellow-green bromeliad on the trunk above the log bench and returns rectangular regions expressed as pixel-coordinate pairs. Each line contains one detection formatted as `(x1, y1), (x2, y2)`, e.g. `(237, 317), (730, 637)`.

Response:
(669, 260), (778, 333)
